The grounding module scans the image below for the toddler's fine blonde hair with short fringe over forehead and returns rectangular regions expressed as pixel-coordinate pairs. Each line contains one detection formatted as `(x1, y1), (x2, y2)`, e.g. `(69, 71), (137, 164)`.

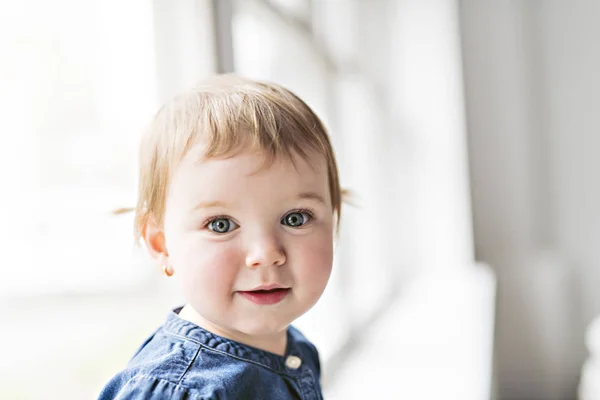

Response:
(131, 75), (343, 242)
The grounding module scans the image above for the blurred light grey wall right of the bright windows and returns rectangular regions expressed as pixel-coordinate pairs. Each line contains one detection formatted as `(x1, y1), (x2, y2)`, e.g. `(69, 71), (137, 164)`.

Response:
(461, 0), (600, 399)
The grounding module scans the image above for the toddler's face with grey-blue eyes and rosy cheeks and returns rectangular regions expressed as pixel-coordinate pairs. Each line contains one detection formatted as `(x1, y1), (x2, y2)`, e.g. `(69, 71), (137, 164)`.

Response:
(159, 145), (334, 335)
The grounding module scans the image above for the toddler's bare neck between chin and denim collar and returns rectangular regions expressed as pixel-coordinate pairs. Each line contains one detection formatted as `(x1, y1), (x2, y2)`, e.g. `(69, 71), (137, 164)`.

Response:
(179, 304), (287, 356)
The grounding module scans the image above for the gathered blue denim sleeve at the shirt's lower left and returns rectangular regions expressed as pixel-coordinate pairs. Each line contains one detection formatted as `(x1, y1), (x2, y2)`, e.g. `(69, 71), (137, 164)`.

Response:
(98, 375), (202, 400)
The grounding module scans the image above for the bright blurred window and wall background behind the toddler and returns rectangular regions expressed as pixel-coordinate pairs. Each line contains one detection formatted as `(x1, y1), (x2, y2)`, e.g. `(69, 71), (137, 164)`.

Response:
(0, 0), (600, 400)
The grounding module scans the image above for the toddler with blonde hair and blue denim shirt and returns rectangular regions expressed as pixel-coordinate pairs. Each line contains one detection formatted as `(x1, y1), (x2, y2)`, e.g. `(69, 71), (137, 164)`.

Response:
(100, 75), (342, 400)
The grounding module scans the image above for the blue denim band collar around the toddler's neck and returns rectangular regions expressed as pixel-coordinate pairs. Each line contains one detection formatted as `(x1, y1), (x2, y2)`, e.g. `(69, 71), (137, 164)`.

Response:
(163, 307), (306, 375)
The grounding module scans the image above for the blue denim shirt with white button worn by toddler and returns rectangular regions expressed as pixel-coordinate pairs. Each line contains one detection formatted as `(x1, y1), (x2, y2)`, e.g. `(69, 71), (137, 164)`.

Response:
(99, 308), (323, 400)
